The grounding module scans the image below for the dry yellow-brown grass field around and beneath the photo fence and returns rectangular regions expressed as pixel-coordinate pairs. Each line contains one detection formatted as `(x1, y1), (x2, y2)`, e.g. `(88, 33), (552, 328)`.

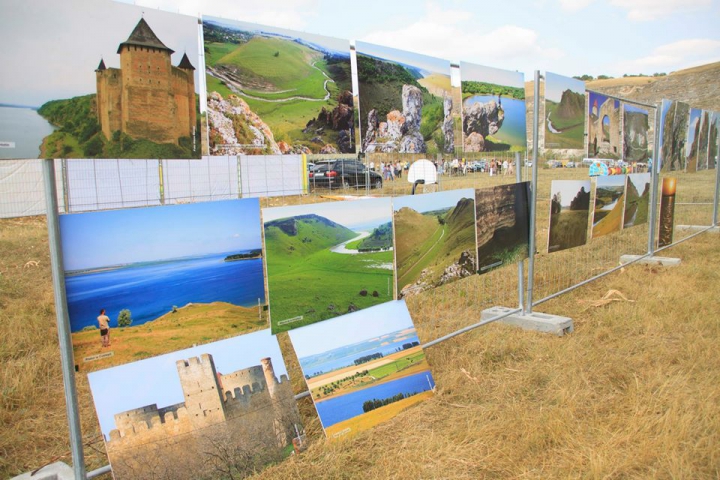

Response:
(0, 164), (720, 479)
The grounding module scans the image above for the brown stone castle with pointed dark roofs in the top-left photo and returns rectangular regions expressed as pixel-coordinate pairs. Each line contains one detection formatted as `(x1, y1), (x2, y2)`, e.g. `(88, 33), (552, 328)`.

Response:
(95, 18), (197, 144)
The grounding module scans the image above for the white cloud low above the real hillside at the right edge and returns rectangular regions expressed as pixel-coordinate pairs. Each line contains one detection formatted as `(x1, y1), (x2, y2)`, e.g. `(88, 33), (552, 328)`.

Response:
(614, 38), (720, 74)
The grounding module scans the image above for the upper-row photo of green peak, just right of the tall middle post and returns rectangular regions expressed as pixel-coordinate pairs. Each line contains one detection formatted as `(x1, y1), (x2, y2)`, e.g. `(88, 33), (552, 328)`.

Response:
(544, 72), (585, 150)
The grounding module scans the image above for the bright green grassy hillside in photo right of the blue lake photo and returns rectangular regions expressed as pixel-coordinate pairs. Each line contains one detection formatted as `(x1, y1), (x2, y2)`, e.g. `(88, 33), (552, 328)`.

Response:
(265, 215), (393, 333)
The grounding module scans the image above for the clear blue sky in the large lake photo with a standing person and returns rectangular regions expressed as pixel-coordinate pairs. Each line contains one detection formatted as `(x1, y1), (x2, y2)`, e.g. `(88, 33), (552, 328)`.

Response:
(60, 198), (262, 270)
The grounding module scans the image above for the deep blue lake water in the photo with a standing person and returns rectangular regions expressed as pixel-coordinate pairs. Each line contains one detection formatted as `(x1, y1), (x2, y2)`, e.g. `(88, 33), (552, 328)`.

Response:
(65, 252), (265, 332)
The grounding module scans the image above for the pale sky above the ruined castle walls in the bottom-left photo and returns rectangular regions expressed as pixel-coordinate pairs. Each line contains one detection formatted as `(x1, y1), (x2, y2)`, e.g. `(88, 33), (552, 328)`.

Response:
(88, 330), (287, 435)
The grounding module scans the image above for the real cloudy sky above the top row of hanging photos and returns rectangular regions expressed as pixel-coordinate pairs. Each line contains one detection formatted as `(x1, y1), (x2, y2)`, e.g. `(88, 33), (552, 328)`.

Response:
(121, 0), (720, 80)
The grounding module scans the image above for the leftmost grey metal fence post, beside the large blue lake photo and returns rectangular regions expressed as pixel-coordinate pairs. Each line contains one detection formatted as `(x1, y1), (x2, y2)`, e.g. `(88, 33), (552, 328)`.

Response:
(43, 159), (85, 480)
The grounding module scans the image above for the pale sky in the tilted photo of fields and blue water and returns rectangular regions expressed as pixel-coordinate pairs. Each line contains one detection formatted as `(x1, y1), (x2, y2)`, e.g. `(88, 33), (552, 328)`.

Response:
(288, 300), (415, 359)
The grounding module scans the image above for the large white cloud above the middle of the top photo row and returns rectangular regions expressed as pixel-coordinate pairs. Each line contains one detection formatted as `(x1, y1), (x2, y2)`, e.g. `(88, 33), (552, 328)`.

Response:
(361, 3), (564, 69)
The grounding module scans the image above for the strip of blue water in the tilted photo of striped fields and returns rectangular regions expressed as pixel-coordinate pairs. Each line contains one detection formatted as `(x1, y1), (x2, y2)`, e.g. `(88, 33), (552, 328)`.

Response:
(315, 370), (435, 428)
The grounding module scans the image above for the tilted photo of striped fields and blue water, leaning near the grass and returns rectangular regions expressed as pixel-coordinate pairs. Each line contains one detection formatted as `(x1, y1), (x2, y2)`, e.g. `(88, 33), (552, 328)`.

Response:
(290, 300), (435, 439)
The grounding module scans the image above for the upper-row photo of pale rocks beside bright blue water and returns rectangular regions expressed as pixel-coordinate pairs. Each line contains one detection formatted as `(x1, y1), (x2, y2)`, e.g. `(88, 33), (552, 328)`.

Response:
(460, 62), (527, 152)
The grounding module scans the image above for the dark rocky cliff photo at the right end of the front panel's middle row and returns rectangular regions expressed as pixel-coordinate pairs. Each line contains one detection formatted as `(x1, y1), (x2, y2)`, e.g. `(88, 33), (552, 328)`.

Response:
(475, 182), (530, 273)
